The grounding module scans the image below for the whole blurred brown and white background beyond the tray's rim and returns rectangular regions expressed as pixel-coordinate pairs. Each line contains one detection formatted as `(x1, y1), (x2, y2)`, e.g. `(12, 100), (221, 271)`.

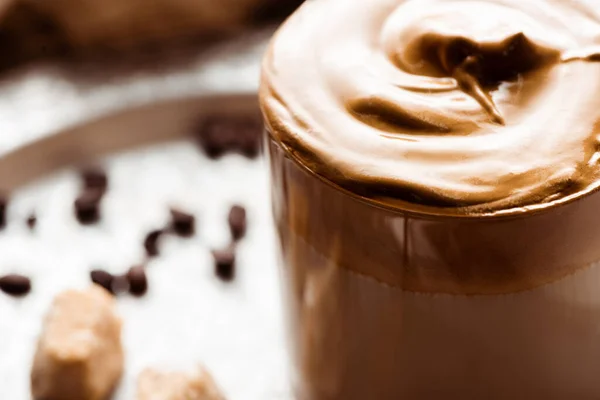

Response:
(0, 0), (302, 152)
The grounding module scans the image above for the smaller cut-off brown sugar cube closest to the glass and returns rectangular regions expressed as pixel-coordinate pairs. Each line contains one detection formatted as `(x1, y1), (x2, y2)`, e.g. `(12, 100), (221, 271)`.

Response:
(136, 367), (224, 400)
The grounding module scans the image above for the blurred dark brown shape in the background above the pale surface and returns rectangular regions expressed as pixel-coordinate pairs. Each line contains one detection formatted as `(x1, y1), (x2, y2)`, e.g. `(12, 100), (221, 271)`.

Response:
(0, 0), (300, 71)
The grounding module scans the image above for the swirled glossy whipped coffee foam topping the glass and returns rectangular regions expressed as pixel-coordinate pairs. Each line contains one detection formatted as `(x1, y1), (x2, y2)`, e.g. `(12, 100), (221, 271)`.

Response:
(261, 0), (600, 213)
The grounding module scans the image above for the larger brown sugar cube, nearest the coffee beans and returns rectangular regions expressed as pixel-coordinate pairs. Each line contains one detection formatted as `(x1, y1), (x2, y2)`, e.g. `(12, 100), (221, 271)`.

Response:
(31, 285), (123, 400)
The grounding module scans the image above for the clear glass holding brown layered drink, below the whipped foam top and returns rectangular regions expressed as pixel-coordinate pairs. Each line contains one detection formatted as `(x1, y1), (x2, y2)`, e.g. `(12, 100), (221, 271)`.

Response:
(266, 132), (600, 400)
